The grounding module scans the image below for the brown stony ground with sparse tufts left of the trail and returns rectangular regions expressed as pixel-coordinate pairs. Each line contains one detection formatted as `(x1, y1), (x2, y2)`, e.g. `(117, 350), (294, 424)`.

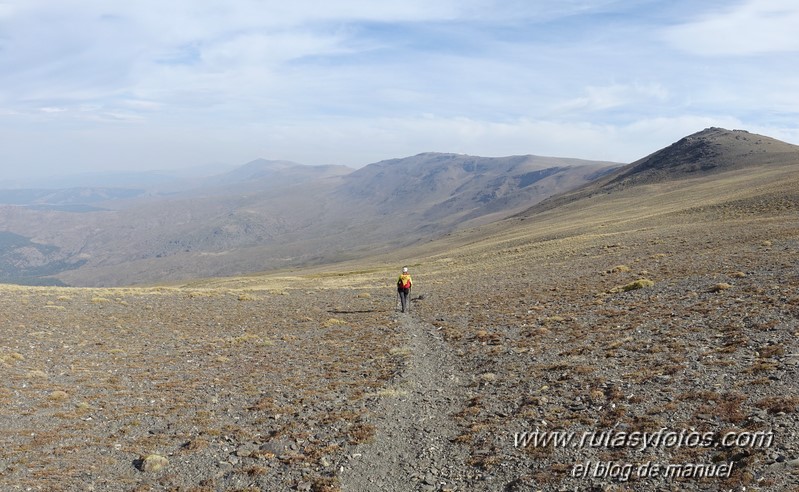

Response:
(0, 287), (404, 491)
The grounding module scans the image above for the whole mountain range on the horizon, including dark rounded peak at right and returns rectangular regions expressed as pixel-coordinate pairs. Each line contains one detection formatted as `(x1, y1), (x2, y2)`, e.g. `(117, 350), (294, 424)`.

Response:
(0, 128), (799, 286)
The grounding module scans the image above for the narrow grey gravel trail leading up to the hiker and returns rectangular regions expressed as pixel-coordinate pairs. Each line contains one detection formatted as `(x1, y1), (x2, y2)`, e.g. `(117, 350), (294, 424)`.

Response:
(341, 314), (467, 492)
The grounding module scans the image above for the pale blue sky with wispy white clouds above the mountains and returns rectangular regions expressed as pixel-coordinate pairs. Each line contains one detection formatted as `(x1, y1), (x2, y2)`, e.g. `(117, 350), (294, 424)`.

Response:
(0, 0), (799, 180)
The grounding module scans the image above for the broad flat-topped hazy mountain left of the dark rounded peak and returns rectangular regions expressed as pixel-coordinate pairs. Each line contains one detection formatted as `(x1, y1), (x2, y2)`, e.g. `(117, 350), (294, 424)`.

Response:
(338, 153), (617, 226)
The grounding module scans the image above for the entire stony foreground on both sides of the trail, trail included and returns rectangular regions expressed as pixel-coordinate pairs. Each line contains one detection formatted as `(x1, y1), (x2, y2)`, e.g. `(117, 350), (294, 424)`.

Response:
(0, 208), (799, 491)
